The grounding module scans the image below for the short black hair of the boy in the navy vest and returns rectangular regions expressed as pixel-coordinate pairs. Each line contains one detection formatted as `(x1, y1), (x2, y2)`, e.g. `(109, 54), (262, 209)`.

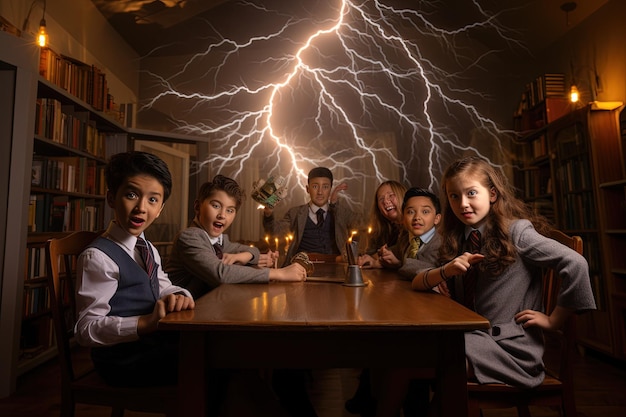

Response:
(104, 151), (172, 203)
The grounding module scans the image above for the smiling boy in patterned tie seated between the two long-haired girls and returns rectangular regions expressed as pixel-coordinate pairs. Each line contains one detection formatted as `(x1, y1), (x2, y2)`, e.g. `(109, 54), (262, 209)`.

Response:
(399, 187), (441, 280)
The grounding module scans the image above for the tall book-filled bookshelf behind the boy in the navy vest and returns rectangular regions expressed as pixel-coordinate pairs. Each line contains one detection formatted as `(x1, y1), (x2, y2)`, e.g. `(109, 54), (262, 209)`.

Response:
(17, 49), (127, 374)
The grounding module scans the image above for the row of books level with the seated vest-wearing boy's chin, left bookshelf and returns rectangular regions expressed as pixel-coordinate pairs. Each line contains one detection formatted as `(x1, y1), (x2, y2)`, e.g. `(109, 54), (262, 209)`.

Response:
(28, 194), (104, 232)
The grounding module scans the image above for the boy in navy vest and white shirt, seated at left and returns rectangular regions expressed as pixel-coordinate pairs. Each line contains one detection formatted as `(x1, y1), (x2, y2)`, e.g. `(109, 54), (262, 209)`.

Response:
(75, 152), (195, 386)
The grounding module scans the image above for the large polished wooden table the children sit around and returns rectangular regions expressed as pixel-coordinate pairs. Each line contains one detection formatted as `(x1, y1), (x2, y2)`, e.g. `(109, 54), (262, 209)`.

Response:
(159, 264), (489, 417)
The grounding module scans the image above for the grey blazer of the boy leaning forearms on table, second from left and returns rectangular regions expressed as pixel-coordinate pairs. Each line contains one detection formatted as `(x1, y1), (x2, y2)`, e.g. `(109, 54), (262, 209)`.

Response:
(165, 224), (270, 298)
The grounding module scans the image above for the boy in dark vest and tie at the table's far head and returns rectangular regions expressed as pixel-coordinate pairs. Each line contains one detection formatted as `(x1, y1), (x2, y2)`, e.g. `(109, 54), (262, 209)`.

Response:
(263, 167), (361, 264)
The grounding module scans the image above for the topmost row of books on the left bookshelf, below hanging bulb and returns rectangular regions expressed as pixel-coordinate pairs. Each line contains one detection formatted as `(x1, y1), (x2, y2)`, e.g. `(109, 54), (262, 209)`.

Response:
(39, 48), (112, 111)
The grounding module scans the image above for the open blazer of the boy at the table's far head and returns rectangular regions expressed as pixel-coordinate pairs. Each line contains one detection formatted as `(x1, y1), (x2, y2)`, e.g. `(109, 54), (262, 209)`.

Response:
(263, 203), (361, 265)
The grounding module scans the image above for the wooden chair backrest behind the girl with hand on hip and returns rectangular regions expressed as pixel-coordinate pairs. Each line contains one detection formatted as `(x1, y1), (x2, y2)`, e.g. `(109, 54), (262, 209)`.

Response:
(543, 230), (583, 383)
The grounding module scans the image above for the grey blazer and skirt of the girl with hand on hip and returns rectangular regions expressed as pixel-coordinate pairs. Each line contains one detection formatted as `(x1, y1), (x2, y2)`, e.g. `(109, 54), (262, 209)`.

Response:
(454, 220), (596, 388)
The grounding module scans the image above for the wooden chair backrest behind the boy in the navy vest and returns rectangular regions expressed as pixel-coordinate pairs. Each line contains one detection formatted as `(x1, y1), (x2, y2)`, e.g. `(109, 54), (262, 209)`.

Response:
(46, 231), (99, 386)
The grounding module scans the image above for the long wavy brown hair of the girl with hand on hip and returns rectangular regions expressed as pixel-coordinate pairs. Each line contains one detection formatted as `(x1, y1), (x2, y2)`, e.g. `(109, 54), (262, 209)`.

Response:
(439, 157), (551, 276)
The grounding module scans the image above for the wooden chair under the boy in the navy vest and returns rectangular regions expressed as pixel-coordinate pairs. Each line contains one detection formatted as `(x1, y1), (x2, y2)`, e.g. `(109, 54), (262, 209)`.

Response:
(46, 232), (176, 417)
